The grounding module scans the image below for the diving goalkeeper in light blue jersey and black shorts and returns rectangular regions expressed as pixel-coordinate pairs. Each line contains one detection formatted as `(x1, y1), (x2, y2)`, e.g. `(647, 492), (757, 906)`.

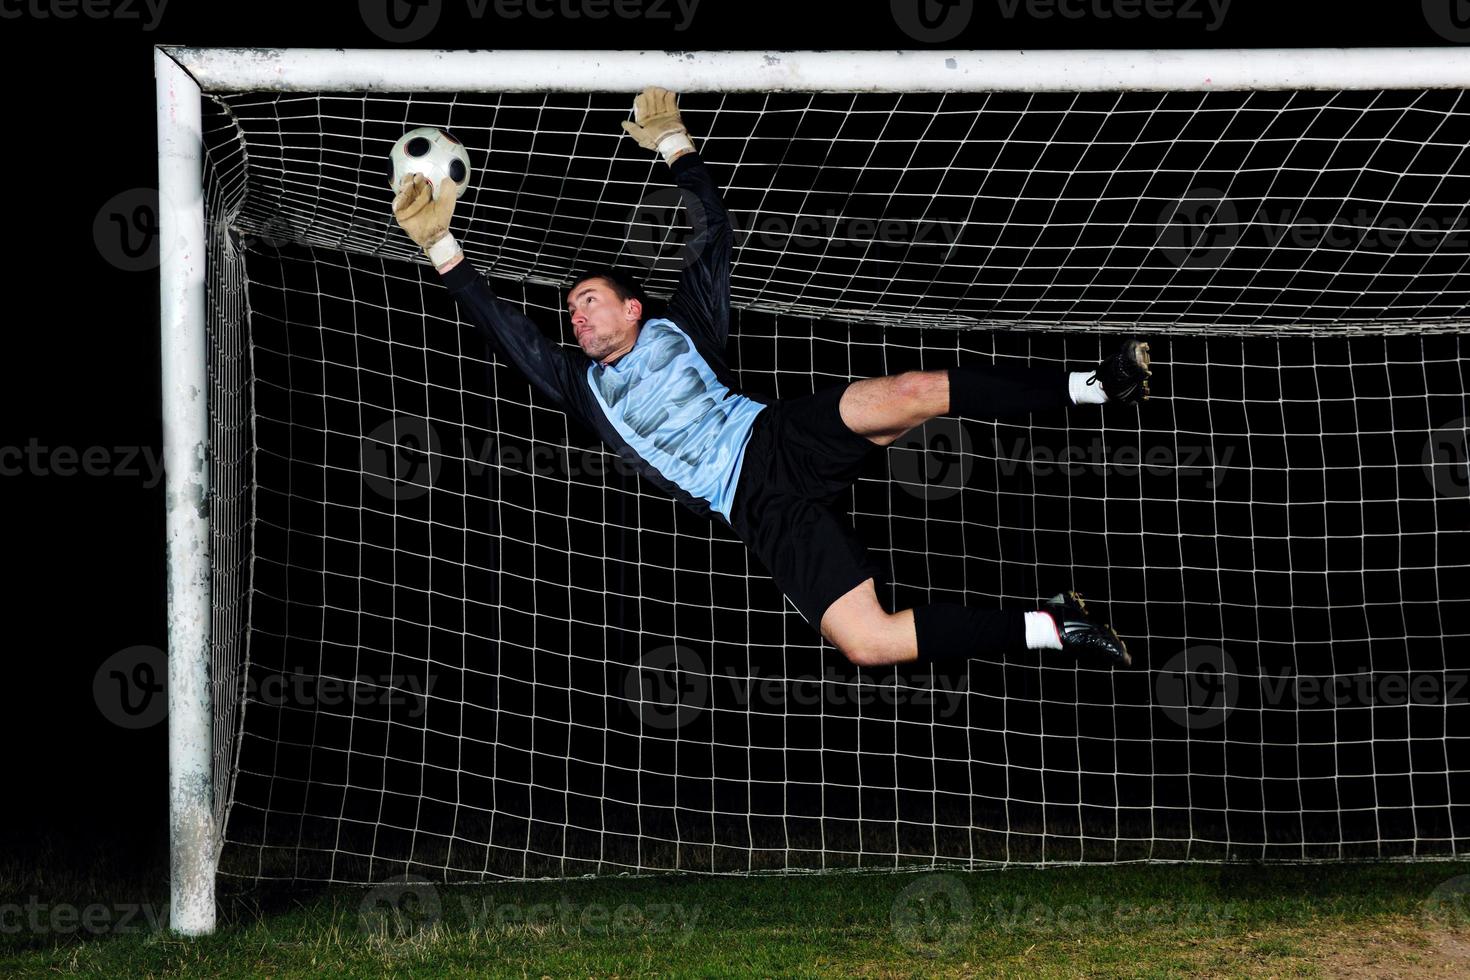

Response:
(392, 88), (1151, 667)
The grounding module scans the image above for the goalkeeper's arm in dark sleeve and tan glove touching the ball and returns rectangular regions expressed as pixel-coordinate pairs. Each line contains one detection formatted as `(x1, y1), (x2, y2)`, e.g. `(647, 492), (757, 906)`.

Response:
(392, 175), (576, 410)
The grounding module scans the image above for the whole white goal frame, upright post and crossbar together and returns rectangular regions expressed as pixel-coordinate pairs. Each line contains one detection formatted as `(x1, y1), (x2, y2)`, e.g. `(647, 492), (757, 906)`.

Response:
(154, 46), (1470, 936)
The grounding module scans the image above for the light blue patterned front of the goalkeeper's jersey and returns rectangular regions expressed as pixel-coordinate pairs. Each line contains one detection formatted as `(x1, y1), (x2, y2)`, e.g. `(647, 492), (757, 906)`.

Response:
(587, 319), (766, 520)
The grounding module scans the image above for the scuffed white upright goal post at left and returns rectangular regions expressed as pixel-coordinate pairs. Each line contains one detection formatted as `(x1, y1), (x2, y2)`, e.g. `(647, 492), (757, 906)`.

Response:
(153, 50), (218, 936)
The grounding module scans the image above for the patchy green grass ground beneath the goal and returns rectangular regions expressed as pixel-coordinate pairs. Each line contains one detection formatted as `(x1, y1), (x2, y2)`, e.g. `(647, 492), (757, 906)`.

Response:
(0, 862), (1470, 977)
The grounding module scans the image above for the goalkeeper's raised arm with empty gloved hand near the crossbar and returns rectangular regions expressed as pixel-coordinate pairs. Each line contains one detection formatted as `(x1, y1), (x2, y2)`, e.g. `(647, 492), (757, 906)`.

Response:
(623, 87), (735, 350)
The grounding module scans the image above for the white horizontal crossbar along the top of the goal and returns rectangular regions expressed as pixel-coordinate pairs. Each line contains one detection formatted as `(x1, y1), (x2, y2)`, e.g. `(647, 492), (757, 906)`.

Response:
(159, 47), (1470, 93)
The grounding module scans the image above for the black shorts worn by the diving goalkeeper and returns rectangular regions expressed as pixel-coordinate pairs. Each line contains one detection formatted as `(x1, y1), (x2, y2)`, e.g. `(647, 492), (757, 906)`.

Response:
(731, 382), (883, 633)
